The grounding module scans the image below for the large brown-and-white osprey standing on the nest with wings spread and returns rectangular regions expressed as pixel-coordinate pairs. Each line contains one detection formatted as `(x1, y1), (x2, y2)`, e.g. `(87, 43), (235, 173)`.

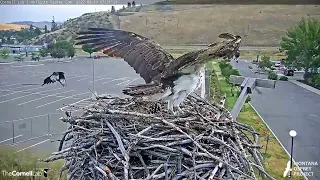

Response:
(76, 28), (241, 114)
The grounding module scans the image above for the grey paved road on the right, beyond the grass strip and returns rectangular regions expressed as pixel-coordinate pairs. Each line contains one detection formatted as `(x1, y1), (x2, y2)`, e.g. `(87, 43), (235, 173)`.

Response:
(232, 61), (320, 180)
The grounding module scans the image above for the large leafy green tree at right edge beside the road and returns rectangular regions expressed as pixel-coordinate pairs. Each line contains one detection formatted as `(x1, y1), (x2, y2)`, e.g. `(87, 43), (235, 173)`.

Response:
(280, 18), (320, 79)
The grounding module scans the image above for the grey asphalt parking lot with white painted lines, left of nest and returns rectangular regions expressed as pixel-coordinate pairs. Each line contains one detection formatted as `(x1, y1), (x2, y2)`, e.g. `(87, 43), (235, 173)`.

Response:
(0, 57), (144, 152)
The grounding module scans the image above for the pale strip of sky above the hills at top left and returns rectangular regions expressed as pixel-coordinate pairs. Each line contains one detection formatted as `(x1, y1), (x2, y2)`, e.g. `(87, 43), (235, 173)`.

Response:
(0, 5), (123, 23)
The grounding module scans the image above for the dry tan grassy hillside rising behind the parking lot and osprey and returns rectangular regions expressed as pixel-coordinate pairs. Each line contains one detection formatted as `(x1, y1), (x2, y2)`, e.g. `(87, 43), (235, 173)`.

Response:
(30, 5), (320, 46)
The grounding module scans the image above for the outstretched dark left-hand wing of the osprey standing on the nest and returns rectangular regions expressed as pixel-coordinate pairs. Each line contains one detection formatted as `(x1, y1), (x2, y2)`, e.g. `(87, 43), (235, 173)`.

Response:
(76, 28), (174, 83)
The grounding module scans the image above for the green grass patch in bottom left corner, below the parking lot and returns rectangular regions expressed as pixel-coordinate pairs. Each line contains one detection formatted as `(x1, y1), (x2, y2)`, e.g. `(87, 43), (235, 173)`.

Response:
(0, 146), (66, 180)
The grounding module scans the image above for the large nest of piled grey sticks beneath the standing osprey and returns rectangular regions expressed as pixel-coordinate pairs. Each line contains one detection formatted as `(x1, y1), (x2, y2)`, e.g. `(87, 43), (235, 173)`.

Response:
(43, 96), (274, 180)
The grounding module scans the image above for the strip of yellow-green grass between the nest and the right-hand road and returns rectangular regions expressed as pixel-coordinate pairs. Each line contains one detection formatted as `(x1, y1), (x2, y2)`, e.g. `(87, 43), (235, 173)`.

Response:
(211, 63), (304, 180)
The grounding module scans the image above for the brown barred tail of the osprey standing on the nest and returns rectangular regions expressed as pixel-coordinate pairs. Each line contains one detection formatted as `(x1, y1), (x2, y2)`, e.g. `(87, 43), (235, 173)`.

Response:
(122, 84), (171, 101)
